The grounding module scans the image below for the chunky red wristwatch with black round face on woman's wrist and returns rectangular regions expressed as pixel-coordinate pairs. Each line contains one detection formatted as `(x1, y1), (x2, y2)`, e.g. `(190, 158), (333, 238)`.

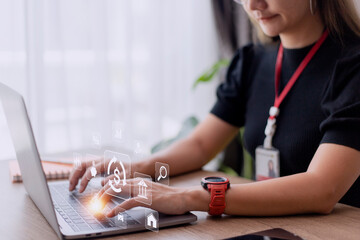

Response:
(201, 177), (230, 216)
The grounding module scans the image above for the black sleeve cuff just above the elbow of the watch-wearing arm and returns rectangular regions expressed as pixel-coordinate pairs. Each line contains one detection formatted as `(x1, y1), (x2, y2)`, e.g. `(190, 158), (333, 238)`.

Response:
(321, 126), (360, 151)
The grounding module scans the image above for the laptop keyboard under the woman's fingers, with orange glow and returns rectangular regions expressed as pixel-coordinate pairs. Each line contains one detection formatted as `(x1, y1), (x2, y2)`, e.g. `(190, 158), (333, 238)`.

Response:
(49, 184), (139, 232)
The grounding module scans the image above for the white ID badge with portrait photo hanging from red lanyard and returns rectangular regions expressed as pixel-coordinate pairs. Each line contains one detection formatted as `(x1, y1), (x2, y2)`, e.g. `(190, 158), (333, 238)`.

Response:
(255, 146), (280, 181)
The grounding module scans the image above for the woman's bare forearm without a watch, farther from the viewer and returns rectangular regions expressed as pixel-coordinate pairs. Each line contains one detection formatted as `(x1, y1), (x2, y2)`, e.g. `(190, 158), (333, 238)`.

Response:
(134, 114), (238, 176)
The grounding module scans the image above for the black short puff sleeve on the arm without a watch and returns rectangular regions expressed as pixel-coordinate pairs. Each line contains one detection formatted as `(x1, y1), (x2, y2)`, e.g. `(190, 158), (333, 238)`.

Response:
(210, 45), (253, 127)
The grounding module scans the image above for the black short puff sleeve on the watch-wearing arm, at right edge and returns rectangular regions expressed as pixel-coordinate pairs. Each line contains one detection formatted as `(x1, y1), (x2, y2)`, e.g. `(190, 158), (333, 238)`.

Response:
(320, 52), (360, 151)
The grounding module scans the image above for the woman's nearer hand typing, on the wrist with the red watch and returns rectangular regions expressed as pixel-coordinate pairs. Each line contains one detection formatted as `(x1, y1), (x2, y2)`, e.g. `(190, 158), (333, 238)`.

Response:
(97, 179), (210, 218)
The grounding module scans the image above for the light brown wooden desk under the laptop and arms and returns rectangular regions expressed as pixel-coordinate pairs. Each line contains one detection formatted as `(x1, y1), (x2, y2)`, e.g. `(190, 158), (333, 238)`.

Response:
(0, 161), (360, 239)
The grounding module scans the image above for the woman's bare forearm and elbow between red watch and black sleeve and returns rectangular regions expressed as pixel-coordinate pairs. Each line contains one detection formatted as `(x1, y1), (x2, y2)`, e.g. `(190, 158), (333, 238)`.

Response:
(193, 144), (360, 216)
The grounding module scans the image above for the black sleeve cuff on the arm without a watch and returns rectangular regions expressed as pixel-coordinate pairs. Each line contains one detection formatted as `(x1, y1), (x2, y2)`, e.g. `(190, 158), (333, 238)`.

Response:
(210, 101), (244, 127)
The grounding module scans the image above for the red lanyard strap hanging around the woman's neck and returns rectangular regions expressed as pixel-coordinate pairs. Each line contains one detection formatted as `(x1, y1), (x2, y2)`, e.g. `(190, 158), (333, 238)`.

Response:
(270, 30), (329, 119)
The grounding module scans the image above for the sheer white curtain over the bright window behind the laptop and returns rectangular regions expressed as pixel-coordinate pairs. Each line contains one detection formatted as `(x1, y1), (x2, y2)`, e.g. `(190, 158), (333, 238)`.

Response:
(0, 0), (217, 159)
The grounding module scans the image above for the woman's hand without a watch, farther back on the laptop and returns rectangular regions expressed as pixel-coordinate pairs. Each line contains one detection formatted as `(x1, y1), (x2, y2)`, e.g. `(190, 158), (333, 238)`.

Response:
(69, 158), (137, 193)
